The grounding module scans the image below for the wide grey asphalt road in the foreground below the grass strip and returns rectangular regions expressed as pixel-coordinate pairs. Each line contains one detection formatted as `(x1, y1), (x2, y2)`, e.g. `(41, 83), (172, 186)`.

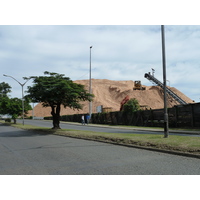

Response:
(0, 124), (200, 175)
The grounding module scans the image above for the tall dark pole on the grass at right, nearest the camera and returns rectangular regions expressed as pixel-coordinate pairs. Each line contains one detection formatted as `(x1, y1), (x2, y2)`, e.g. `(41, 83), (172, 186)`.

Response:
(161, 25), (169, 138)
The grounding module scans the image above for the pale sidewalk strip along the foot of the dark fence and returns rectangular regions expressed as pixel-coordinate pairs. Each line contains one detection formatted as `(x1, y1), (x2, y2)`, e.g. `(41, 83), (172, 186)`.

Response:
(61, 121), (200, 135)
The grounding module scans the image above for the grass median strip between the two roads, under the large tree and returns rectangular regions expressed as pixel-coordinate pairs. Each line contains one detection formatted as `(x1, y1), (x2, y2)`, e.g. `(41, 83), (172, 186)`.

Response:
(1, 124), (200, 157)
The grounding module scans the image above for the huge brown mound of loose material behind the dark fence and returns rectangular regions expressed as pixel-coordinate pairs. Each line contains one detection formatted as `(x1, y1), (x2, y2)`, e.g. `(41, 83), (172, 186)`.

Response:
(30, 79), (193, 117)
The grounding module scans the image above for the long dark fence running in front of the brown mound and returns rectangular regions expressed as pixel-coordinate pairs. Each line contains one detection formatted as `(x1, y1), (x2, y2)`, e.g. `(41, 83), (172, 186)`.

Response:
(45, 103), (200, 128)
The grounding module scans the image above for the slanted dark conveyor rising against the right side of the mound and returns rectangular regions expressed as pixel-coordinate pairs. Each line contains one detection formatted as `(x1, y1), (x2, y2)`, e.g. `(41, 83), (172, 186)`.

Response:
(144, 72), (187, 105)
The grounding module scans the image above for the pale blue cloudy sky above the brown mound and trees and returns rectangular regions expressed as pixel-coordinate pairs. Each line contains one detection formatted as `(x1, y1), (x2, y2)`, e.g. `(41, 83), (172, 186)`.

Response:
(0, 25), (200, 102)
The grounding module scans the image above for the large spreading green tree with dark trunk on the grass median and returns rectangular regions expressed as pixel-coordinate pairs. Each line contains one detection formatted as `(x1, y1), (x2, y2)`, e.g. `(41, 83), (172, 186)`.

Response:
(27, 71), (93, 129)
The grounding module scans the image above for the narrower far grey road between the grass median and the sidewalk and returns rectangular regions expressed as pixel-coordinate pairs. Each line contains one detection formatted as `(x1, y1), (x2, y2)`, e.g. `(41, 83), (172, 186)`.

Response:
(17, 119), (200, 137)
